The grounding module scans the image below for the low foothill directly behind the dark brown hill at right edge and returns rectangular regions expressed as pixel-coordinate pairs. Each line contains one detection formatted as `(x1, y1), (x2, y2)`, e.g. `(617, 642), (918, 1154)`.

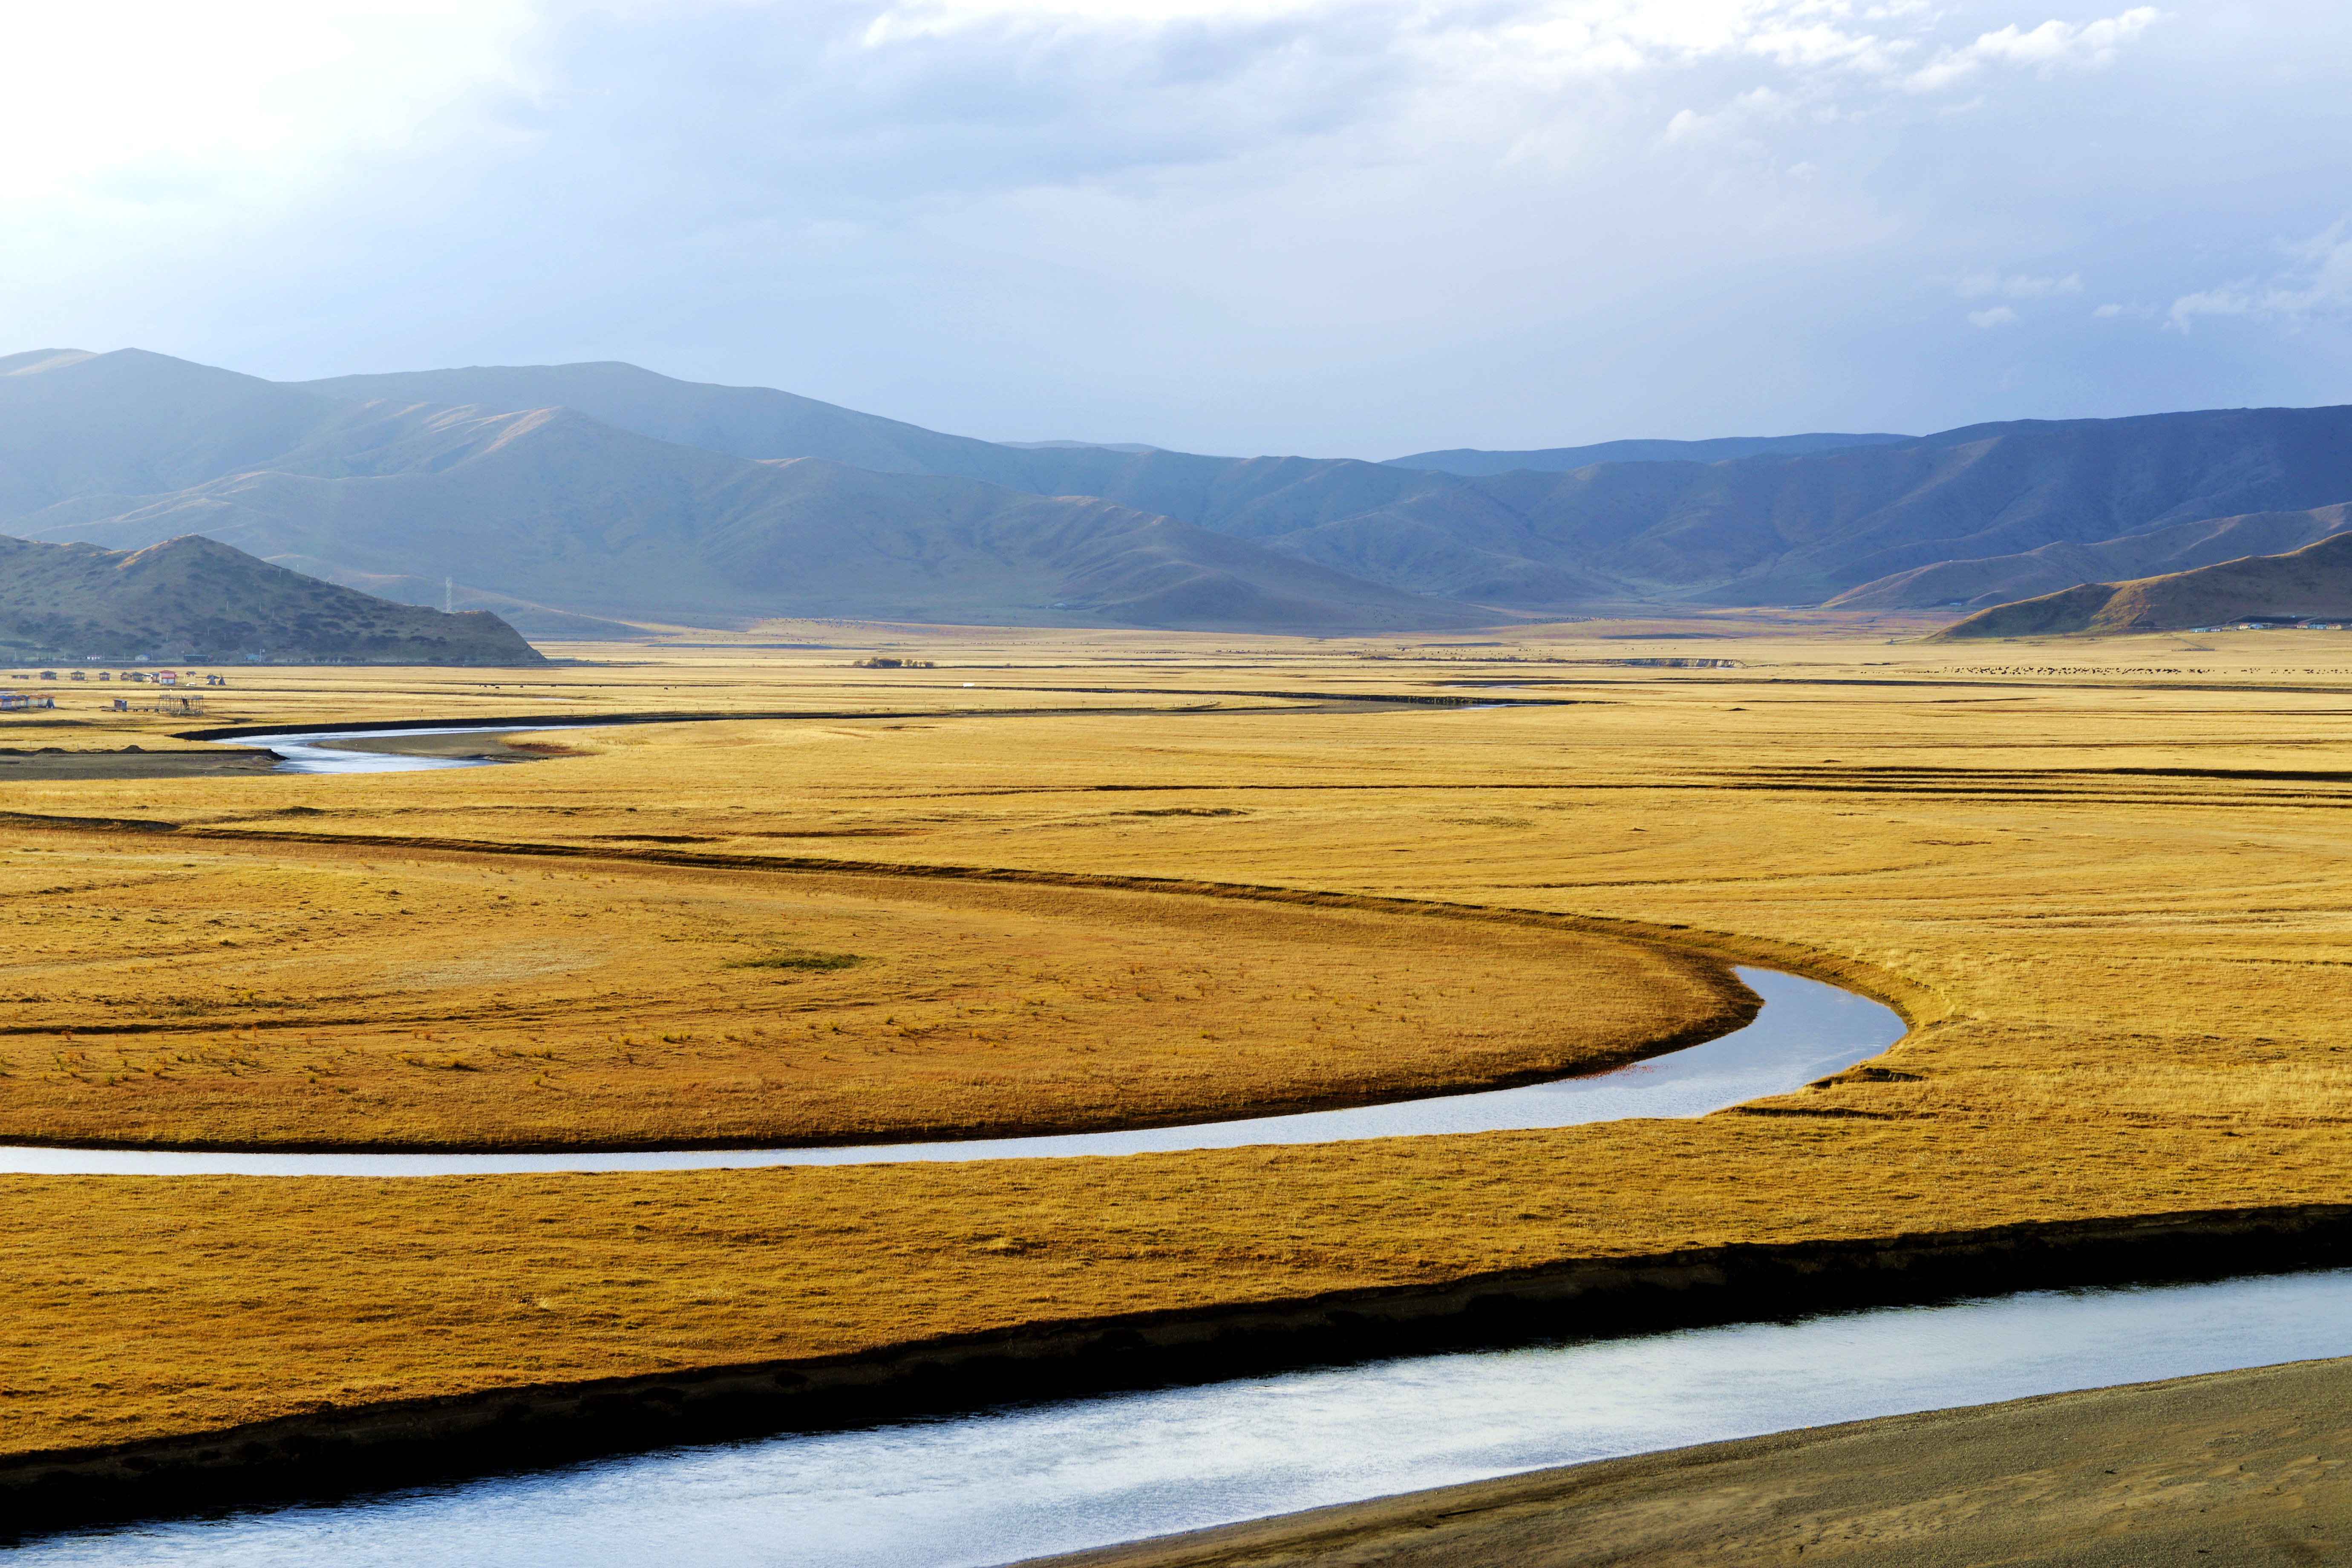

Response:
(1830, 503), (2352, 609)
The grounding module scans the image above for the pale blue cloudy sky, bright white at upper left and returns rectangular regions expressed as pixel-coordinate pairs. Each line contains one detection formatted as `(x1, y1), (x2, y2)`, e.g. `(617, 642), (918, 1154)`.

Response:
(0, 0), (2352, 458)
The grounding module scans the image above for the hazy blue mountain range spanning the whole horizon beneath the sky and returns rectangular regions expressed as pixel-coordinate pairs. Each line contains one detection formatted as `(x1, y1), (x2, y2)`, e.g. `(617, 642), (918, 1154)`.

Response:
(0, 350), (2352, 635)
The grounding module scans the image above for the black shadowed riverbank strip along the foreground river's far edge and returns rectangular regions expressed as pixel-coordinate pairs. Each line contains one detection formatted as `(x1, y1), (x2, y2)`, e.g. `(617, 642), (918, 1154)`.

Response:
(0, 1213), (2352, 1531)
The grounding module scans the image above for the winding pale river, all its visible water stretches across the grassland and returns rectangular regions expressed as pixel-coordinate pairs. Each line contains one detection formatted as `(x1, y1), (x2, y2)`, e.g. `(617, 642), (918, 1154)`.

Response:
(23, 729), (2352, 1568)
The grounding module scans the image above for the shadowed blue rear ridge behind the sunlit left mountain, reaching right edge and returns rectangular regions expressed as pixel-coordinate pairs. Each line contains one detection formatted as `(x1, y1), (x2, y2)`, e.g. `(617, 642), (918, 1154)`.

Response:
(280, 364), (2352, 611)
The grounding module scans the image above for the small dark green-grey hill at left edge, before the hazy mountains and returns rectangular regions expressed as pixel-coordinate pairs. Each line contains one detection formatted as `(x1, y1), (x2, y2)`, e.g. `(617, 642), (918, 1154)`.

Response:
(0, 533), (546, 665)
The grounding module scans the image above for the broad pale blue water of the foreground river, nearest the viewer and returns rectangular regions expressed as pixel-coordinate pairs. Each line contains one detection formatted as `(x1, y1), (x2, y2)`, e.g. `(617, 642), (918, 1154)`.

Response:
(12, 1269), (2352, 1568)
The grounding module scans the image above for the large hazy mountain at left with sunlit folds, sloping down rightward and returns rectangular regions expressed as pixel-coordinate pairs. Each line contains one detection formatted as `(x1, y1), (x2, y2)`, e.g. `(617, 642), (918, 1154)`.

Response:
(18, 353), (1482, 635)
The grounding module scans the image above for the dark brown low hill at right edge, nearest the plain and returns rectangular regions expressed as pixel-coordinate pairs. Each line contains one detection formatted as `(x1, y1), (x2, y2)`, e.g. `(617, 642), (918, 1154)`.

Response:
(1933, 533), (2352, 642)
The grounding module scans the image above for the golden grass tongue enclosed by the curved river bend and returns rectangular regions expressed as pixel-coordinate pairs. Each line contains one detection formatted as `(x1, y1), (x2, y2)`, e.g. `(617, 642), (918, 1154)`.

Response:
(0, 835), (1752, 1150)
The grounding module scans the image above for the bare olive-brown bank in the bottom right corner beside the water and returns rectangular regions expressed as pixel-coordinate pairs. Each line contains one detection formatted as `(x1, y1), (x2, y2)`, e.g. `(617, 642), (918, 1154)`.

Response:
(1023, 1359), (2352, 1568)
